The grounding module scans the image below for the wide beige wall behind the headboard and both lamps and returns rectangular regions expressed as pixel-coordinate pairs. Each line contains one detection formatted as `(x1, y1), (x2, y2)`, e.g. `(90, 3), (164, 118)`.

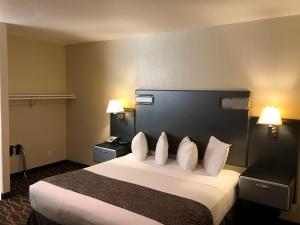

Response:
(66, 16), (300, 221)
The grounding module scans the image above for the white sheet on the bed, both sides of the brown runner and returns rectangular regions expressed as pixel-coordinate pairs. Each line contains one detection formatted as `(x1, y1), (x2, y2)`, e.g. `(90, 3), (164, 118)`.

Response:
(30, 154), (239, 225)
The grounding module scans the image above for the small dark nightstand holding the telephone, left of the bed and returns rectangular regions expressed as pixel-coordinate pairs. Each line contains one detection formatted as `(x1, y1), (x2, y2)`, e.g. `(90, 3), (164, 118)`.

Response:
(93, 143), (131, 163)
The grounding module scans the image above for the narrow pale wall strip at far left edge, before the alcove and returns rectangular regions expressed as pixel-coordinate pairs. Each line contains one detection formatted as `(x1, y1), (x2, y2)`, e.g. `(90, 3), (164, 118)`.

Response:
(0, 23), (10, 194)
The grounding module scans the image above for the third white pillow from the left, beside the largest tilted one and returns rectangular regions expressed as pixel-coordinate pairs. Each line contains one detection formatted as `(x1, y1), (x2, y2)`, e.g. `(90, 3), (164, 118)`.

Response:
(178, 140), (198, 170)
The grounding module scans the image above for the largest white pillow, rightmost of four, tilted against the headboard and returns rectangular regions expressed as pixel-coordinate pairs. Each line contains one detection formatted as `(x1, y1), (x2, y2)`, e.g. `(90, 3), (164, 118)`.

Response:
(203, 136), (231, 176)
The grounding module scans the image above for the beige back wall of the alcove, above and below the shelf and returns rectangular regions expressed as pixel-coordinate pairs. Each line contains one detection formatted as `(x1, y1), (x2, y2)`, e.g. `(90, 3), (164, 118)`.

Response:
(8, 35), (66, 173)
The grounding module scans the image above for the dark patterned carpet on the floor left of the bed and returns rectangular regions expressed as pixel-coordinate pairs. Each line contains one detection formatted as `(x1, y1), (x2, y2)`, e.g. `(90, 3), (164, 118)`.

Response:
(0, 161), (84, 225)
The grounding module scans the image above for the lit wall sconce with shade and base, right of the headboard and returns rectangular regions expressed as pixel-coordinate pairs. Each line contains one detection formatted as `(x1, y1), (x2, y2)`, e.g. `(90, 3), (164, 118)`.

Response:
(257, 106), (282, 139)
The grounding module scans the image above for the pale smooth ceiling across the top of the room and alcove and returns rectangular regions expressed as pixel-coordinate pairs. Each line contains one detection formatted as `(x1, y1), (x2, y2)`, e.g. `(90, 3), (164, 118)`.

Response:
(0, 0), (300, 44)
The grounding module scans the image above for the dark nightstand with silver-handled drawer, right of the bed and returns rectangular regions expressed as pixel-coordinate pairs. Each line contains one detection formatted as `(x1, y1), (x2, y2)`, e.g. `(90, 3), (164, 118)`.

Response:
(239, 165), (295, 211)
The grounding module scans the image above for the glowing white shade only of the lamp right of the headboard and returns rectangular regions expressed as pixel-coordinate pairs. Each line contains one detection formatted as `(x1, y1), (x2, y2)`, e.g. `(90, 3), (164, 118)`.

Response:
(257, 106), (282, 125)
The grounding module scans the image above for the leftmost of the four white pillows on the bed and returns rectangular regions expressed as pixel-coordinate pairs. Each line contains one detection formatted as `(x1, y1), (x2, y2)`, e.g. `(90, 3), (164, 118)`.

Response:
(131, 132), (148, 161)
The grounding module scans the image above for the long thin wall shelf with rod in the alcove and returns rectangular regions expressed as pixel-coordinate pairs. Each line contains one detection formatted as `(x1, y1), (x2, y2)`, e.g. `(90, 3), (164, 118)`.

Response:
(8, 94), (76, 107)
